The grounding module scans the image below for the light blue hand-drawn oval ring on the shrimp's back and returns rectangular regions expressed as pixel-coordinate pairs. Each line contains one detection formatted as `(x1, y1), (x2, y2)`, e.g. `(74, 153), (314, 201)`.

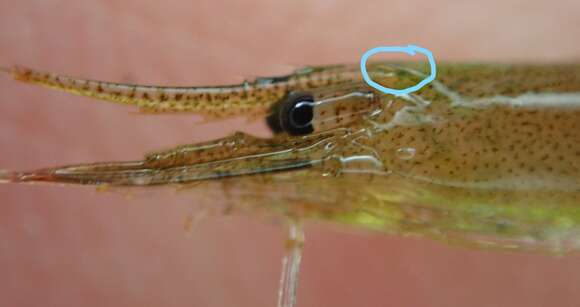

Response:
(360, 45), (437, 96)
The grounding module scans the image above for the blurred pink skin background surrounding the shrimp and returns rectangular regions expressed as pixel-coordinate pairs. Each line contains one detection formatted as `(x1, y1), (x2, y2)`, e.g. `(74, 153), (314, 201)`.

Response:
(0, 0), (580, 307)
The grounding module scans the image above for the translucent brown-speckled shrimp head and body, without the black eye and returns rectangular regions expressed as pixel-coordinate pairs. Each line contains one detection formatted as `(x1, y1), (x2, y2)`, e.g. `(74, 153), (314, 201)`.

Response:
(3, 63), (580, 253)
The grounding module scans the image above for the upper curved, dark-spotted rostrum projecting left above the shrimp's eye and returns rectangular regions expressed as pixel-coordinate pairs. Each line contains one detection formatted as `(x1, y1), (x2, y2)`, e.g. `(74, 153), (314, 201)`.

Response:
(1, 66), (360, 118)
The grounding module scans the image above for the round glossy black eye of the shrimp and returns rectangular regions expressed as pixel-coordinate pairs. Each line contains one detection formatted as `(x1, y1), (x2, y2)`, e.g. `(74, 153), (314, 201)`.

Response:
(267, 92), (314, 135)
